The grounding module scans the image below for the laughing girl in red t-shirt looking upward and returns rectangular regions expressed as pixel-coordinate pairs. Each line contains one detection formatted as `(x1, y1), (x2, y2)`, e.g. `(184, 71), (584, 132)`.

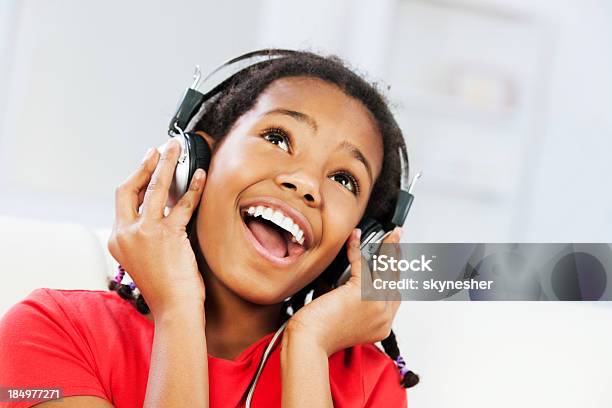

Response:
(0, 52), (418, 407)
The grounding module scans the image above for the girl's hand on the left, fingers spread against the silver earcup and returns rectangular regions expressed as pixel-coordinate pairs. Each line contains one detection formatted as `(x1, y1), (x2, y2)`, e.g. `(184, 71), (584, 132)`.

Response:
(108, 139), (206, 316)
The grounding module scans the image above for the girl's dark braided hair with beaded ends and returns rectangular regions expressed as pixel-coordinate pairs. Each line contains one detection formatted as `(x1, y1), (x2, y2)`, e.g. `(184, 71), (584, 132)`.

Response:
(108, 51), (419, 388)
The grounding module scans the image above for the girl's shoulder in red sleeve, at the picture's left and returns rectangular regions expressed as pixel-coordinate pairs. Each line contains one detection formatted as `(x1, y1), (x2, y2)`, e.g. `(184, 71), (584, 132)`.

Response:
(0, 288), (153, 400)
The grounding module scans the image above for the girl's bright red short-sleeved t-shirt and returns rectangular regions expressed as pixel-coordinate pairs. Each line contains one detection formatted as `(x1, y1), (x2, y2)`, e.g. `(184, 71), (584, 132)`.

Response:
(0, 288), (407, 408)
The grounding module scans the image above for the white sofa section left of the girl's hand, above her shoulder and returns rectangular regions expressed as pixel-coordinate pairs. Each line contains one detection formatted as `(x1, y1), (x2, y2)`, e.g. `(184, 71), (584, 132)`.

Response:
(0, 216), (116, 314)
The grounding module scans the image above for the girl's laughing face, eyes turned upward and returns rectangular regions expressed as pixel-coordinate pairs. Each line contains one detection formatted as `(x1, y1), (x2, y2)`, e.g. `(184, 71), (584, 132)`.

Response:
(196, 77), (383, 305)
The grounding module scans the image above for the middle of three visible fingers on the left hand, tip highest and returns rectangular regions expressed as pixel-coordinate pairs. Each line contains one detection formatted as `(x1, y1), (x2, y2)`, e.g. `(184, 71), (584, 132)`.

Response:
(142, 139), (181, 218)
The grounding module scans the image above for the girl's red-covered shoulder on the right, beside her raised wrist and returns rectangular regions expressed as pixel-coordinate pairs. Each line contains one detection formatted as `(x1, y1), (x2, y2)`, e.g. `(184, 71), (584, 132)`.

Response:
(329, 344), (406, 407)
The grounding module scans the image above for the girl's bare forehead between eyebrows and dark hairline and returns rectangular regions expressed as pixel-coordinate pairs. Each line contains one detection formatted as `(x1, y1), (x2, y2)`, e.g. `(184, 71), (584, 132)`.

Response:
(250, 77), (383, 175)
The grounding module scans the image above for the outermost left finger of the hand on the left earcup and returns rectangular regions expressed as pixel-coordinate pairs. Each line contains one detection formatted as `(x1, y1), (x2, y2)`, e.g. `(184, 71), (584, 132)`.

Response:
(115, 147), (159, 223)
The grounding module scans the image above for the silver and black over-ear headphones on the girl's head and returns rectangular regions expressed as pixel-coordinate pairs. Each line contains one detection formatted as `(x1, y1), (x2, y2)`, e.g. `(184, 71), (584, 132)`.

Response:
(159, 49), (422, 287)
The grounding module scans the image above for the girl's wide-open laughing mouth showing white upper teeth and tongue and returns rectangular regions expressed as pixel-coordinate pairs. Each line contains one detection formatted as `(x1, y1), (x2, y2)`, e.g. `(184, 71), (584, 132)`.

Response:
(240, 205), (306, 264)
